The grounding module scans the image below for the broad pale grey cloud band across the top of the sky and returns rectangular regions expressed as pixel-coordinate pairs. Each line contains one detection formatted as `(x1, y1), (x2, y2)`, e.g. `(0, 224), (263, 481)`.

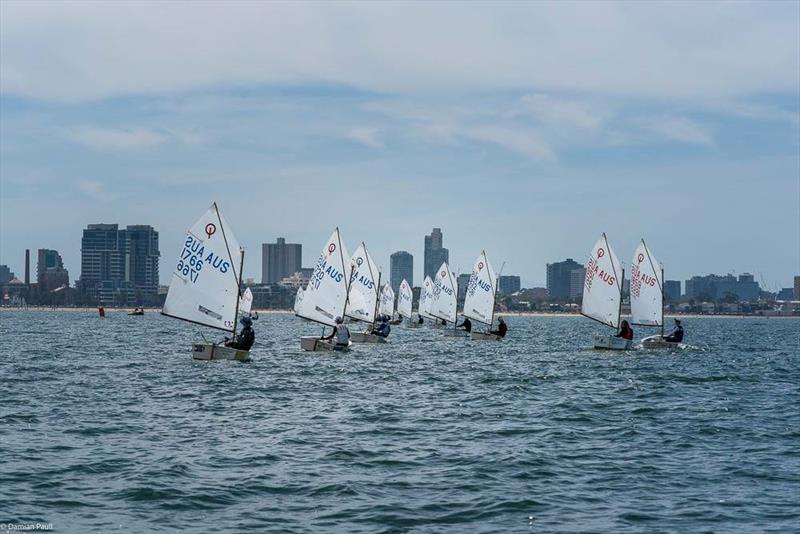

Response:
(0, 1), (800, 100)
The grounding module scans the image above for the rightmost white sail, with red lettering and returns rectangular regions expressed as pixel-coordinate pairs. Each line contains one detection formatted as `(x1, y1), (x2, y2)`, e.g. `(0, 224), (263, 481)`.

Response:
(630, 239), (664, 326)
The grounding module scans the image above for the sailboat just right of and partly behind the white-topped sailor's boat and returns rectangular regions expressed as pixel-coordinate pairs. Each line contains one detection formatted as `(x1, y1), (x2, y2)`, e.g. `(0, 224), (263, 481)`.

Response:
(346, 245), (386, 343)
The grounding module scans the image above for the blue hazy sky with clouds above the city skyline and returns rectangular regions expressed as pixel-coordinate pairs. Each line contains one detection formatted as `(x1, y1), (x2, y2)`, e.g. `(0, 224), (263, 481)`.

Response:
(0, 0), (800, 290)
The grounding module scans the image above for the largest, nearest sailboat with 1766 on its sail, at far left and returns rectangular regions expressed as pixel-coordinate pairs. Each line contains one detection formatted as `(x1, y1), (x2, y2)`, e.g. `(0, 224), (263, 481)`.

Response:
(161, 202), (250, 361)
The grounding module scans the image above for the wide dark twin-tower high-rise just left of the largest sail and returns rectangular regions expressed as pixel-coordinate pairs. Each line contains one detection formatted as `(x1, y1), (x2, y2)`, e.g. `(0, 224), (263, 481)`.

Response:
(79, 224), (160, 305)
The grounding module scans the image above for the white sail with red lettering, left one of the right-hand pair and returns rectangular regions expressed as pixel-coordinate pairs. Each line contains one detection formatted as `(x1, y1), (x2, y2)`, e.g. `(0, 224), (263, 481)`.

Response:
(581, 234), (623, 328)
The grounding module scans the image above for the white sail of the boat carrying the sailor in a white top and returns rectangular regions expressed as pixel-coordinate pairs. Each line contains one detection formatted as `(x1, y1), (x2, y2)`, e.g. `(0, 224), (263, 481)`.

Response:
(294, 228), (350, 326)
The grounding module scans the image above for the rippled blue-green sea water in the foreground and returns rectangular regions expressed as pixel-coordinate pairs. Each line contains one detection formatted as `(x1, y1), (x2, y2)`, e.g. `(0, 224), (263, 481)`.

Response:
(0, 311), (800, 532)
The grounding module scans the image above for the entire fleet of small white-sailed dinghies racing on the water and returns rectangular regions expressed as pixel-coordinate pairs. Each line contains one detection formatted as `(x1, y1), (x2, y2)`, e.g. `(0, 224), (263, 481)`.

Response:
(161, 203), (680, 361)
